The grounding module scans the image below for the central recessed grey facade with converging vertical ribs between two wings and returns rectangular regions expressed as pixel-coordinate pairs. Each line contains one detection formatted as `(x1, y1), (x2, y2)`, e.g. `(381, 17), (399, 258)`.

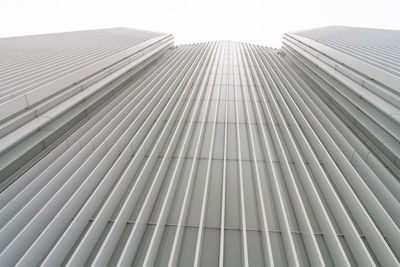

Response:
(0, 28), (400, 266)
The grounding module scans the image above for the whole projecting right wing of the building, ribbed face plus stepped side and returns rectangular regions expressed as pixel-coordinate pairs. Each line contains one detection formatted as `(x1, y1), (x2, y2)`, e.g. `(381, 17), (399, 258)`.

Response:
(283, 27), (400, 191)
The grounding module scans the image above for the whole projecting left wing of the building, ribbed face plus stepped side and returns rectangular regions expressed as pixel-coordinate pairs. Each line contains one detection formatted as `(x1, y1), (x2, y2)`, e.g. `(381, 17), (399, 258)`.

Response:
(0, 29), (173, 186)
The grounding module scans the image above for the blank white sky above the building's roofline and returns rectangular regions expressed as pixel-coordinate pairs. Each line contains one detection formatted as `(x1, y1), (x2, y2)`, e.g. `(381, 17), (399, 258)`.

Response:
(0, 0), (400, 47)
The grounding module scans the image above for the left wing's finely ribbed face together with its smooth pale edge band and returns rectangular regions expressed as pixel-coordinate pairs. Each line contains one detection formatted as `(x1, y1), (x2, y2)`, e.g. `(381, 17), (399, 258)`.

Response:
(0, 28), (173, 120)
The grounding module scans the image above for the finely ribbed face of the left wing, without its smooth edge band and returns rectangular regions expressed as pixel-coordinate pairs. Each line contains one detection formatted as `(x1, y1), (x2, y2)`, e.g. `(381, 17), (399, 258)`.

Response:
(0, 29), (163, 103)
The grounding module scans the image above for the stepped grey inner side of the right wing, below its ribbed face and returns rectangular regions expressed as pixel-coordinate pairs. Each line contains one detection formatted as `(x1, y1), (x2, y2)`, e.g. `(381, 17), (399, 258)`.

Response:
(284, 34), (400, 204)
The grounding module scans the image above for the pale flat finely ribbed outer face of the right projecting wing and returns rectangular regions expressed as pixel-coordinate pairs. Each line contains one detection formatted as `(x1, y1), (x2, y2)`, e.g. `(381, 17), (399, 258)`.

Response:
(287, 26), (400, 93)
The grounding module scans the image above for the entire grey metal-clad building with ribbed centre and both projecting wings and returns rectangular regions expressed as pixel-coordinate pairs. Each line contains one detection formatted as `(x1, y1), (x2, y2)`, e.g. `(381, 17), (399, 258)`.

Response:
(0, 26), (400, 267)
